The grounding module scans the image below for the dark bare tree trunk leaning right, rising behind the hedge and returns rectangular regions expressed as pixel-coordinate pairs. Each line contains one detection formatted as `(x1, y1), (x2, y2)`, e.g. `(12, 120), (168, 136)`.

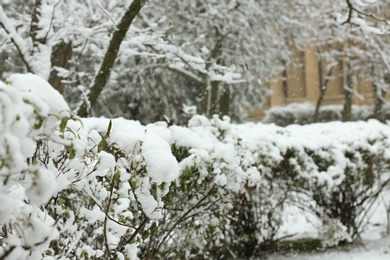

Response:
(77, 0), (145, 117)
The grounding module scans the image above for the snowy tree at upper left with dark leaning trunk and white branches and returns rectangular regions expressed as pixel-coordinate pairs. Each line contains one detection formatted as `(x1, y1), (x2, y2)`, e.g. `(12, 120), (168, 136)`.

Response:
(0, 0), (143, 111)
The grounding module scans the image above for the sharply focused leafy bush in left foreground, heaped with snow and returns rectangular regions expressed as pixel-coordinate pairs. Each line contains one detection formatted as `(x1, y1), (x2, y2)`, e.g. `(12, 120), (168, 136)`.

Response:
(0, 74), (179, 259)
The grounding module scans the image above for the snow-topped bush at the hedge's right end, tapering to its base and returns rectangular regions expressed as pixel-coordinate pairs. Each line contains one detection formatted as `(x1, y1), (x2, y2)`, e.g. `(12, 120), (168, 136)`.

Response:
(239, 120), (390, 246)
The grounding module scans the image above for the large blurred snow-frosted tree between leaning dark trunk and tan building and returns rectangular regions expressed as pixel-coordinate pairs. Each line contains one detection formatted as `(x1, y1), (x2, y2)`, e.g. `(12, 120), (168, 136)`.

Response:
(96, 1), (314, 122)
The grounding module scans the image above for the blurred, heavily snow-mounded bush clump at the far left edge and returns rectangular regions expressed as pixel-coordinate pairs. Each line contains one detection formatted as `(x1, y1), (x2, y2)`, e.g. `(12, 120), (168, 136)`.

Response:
(0, 75), (70, 259)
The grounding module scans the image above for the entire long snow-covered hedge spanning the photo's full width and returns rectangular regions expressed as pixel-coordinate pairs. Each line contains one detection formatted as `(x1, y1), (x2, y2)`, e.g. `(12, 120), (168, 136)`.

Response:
(0, 74), (390, 259)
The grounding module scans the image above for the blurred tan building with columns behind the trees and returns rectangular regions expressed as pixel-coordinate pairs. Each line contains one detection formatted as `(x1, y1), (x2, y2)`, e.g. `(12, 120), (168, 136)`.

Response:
(248, 43), (375, 118)
